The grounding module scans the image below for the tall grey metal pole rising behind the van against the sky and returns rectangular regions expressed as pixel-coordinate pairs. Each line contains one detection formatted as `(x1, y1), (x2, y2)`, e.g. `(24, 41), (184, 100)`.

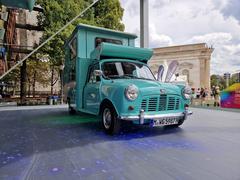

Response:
(140, 0), (149, 48)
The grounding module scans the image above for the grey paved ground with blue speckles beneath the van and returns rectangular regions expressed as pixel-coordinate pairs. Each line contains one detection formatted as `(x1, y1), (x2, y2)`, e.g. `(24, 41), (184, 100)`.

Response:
(0, 106), (240, 180)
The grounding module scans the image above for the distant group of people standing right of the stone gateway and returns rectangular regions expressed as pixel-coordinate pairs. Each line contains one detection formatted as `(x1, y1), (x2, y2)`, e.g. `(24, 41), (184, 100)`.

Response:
(192, 86), (220, 107)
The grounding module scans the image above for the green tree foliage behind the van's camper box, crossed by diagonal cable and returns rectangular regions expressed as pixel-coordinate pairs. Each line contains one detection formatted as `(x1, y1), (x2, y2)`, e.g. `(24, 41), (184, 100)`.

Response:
(4, 0), (124, 95)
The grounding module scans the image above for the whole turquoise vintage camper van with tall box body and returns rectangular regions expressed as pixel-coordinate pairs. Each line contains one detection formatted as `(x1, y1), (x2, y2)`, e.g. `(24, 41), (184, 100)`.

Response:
(64, 24), (191, 134)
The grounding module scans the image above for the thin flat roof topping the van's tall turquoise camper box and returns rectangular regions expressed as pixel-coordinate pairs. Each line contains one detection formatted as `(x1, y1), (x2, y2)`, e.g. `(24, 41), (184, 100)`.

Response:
(64, 24), (137, 46)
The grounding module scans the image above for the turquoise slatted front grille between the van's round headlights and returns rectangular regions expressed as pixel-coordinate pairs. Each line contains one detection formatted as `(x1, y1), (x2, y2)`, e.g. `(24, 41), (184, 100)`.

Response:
(141, 95), (180, 112)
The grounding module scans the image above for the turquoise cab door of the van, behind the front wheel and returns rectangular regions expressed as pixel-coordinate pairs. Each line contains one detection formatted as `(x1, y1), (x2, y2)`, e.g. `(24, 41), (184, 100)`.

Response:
(84, 64), (101, 114)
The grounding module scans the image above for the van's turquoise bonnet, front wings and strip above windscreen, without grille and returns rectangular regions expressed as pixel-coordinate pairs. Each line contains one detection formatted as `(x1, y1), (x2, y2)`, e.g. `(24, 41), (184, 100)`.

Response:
(97, 59), (189, 116)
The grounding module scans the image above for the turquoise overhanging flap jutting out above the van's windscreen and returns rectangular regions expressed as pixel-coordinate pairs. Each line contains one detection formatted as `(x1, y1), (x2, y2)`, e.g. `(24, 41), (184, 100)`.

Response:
(91, 43), (153, 61)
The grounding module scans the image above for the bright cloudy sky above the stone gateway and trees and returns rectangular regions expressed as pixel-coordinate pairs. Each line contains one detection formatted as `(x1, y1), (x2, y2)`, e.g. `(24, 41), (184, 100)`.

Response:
(120, 0), (240, 75)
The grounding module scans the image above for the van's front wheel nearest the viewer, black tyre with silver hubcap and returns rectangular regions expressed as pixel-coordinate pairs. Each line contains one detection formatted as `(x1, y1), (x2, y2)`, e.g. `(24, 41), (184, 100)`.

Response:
(101, 103), (121, 135)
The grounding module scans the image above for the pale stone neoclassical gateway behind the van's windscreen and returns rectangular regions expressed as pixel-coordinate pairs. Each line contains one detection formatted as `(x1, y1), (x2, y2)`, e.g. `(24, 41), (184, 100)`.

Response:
(149, 43), (213, 89)
